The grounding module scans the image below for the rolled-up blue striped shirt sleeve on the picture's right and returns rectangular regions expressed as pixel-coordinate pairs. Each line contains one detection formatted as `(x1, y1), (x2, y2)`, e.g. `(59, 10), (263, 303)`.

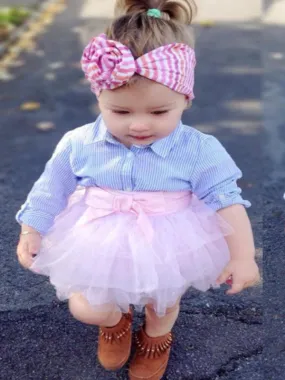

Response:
(191, 136), (251, 211)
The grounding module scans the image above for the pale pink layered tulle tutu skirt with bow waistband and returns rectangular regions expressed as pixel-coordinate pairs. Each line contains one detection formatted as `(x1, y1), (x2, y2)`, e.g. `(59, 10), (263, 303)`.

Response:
(31, 187), (231, 316)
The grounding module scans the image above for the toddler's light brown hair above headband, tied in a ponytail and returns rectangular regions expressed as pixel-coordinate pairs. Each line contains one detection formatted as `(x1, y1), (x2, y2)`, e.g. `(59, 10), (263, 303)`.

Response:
(106, 0), (197, 58)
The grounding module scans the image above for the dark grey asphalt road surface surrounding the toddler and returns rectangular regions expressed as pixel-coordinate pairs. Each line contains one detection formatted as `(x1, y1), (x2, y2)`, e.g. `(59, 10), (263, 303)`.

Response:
(0, 0), (285, 380)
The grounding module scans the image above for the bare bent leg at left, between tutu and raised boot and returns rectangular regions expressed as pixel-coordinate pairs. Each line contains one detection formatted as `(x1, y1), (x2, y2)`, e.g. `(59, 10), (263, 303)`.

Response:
(69, 293), (122, 327)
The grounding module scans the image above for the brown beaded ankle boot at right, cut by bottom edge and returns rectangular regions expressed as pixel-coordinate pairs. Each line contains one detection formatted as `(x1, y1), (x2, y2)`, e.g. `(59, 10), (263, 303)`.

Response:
(129, 328), (172, 380)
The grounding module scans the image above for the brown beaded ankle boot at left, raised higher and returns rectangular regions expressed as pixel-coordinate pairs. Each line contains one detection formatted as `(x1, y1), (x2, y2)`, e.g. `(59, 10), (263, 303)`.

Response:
(98, 312), (133, 371)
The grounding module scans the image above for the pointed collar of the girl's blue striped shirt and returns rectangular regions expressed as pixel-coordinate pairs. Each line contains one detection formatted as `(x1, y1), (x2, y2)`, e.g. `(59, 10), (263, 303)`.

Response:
(87, 115), (182, 158)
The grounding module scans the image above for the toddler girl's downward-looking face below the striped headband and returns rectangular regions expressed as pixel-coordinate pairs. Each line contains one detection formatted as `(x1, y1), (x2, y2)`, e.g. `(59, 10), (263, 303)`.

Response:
(99, 78), (187, 147)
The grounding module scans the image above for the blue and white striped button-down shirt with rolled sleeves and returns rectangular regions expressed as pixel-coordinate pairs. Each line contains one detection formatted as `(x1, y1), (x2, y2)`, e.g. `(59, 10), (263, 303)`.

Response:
(16, 117), (250, 234)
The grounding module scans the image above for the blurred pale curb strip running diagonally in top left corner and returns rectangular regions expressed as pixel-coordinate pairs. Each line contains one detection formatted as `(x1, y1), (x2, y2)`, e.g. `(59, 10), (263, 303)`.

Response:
(0, 0), (62, 59)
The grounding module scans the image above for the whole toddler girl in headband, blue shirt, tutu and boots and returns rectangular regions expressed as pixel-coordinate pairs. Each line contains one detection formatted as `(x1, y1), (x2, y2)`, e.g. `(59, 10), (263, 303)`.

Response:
(17, 0), (259, 380)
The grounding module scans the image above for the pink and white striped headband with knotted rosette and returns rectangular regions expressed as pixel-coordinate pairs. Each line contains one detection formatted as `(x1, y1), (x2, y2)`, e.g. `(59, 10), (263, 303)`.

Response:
(81, 34), (196, 100)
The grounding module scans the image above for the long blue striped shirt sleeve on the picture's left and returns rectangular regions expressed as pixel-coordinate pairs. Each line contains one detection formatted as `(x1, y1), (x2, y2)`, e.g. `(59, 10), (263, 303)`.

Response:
(16, 132), (77, 234)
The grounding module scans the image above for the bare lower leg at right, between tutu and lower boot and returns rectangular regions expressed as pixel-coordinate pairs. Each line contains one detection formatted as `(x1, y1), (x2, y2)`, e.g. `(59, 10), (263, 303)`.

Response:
(145, 299), (180, 338)
